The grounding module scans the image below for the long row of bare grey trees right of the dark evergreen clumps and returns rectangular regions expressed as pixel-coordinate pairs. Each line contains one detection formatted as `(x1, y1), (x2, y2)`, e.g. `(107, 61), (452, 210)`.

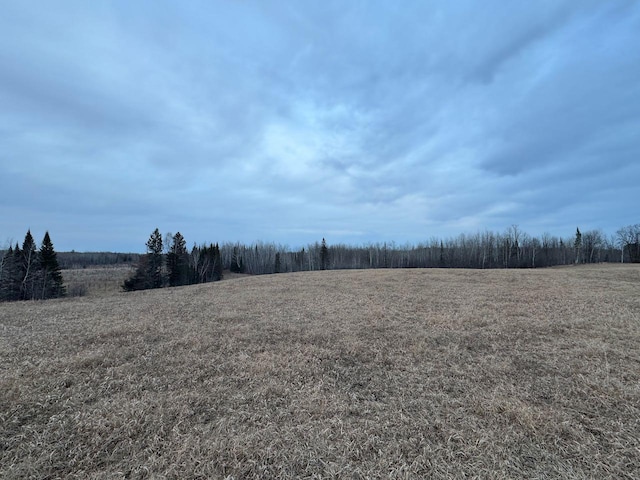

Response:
(214, 224), (640, 274)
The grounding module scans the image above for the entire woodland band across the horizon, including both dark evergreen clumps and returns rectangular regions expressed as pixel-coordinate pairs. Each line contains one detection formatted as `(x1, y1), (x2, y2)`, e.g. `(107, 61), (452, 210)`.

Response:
(0, 224), (640, 301)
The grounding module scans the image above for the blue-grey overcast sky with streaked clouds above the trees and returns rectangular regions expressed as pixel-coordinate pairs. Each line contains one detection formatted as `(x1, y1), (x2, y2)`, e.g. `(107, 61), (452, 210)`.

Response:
(0, 0), (640, 252)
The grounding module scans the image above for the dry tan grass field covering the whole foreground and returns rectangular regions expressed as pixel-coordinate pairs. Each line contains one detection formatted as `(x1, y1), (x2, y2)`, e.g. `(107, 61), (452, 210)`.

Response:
(0, 265), (640, 479)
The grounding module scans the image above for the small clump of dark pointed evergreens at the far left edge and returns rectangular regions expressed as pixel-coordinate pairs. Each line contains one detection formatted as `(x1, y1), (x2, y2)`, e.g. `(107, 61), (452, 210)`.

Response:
(0, 230), (66, 302)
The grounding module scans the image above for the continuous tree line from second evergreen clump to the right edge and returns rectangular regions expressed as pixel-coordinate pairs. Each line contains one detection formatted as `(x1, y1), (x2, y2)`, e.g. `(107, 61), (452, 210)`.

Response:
(123, 224), (640, 291)
